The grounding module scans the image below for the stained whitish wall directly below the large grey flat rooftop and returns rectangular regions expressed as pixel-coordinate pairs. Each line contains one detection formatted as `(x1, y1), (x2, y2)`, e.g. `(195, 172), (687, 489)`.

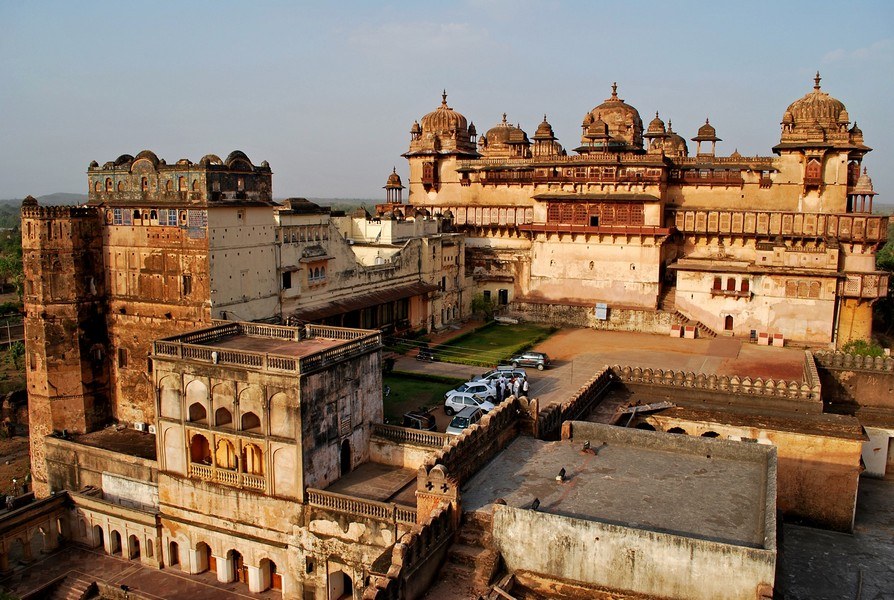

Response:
(494, 505), (776, 600)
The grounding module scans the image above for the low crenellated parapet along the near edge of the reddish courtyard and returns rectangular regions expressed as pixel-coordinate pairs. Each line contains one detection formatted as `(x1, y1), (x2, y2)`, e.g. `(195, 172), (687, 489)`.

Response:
(612, 365), (821, 401)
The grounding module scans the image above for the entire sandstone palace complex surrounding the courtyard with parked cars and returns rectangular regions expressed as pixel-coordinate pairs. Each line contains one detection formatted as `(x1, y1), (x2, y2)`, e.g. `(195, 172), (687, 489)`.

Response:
(0, 75), (894, 600)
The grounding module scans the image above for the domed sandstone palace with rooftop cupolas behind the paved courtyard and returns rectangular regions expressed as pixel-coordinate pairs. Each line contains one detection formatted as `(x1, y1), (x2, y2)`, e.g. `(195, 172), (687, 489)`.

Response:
(398, 74), (887, 346)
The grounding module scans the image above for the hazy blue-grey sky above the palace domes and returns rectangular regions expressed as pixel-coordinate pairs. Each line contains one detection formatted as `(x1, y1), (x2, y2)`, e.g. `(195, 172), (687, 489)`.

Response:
(0, 0), (894, 203)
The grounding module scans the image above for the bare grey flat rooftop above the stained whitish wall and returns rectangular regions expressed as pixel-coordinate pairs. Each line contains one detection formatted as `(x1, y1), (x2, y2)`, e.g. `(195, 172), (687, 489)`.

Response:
(463, 424), (775, 548)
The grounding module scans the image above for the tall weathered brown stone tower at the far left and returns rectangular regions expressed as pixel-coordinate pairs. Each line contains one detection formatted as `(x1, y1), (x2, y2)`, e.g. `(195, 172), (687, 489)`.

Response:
(22, 196), (111, 496)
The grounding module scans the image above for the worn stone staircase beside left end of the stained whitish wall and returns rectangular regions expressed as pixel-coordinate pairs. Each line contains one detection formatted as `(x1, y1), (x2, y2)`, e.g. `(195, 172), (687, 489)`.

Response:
(440, 512), (500, 598)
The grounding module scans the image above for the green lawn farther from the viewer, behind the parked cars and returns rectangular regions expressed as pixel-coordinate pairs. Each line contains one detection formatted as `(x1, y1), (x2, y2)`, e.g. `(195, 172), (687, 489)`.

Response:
(435, 323), (556, 367)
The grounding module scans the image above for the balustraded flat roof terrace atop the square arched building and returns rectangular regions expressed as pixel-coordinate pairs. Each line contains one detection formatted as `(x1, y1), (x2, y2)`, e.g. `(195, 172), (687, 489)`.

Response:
(153, 321), (382, 374)
